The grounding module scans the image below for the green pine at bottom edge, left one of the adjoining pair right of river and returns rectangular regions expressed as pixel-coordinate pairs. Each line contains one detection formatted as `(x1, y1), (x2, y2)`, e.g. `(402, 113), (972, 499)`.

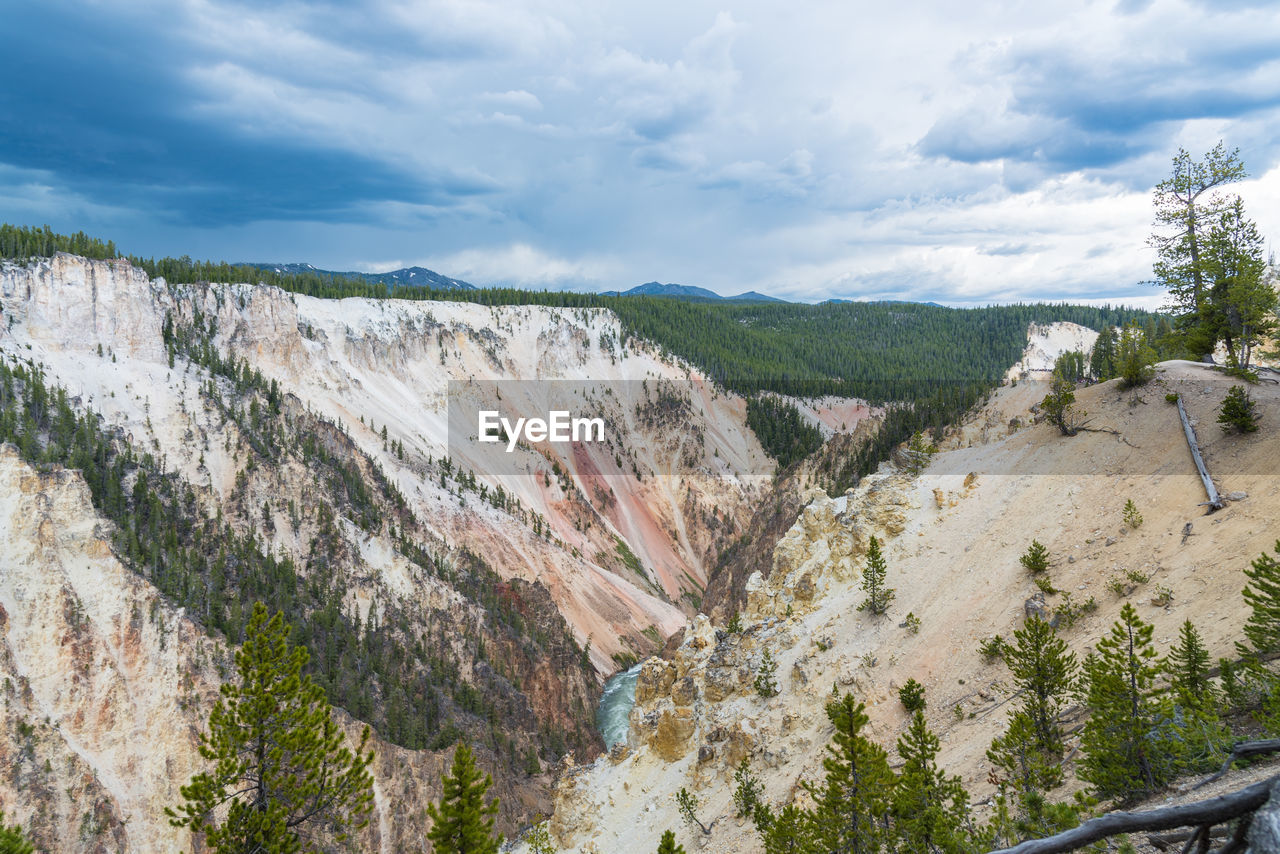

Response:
(804, 694), (893, 854)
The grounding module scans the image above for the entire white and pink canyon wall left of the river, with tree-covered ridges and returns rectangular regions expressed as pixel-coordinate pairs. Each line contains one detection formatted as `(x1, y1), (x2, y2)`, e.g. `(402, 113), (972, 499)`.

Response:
(0, 255), (793, 850)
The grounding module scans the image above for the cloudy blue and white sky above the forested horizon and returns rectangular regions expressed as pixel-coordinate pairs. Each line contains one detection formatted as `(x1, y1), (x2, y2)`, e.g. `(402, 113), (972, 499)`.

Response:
(0, 0), (1280, 307)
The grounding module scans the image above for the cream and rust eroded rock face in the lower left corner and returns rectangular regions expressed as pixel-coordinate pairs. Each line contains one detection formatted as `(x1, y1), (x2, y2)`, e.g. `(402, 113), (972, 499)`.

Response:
(0, 446), (220, 851)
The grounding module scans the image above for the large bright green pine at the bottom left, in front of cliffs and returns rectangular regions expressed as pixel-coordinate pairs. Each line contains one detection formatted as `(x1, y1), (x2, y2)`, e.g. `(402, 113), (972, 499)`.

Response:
(166, 602), (374, 854)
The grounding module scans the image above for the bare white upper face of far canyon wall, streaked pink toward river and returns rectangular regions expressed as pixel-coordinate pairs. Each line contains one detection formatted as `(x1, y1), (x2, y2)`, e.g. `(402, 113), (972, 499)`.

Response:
(0, 255), (768, 672)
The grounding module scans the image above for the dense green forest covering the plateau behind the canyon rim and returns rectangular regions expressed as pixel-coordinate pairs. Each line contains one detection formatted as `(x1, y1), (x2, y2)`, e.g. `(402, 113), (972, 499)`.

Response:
(0, 225), (1156, 481)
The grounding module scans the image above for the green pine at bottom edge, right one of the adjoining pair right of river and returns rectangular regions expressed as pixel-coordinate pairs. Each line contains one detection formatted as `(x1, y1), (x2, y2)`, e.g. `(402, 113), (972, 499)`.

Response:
(891, 711), (969, 853)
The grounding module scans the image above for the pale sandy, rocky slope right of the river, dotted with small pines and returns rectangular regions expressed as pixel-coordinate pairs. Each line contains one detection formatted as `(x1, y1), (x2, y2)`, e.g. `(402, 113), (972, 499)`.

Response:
(532, 362), (1280, 853)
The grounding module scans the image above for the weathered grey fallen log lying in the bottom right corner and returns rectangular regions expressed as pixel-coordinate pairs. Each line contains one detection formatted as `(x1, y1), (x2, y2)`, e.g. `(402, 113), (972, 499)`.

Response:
(992, 777), (1276, 854)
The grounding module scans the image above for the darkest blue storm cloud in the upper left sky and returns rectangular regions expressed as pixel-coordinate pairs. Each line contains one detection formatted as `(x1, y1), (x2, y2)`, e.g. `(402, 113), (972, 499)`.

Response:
(0, 4), (493, 225)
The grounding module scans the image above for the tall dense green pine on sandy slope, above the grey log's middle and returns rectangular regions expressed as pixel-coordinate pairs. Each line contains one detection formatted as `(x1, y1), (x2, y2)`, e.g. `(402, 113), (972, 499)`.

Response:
(1079, 602), (1180, 799)
